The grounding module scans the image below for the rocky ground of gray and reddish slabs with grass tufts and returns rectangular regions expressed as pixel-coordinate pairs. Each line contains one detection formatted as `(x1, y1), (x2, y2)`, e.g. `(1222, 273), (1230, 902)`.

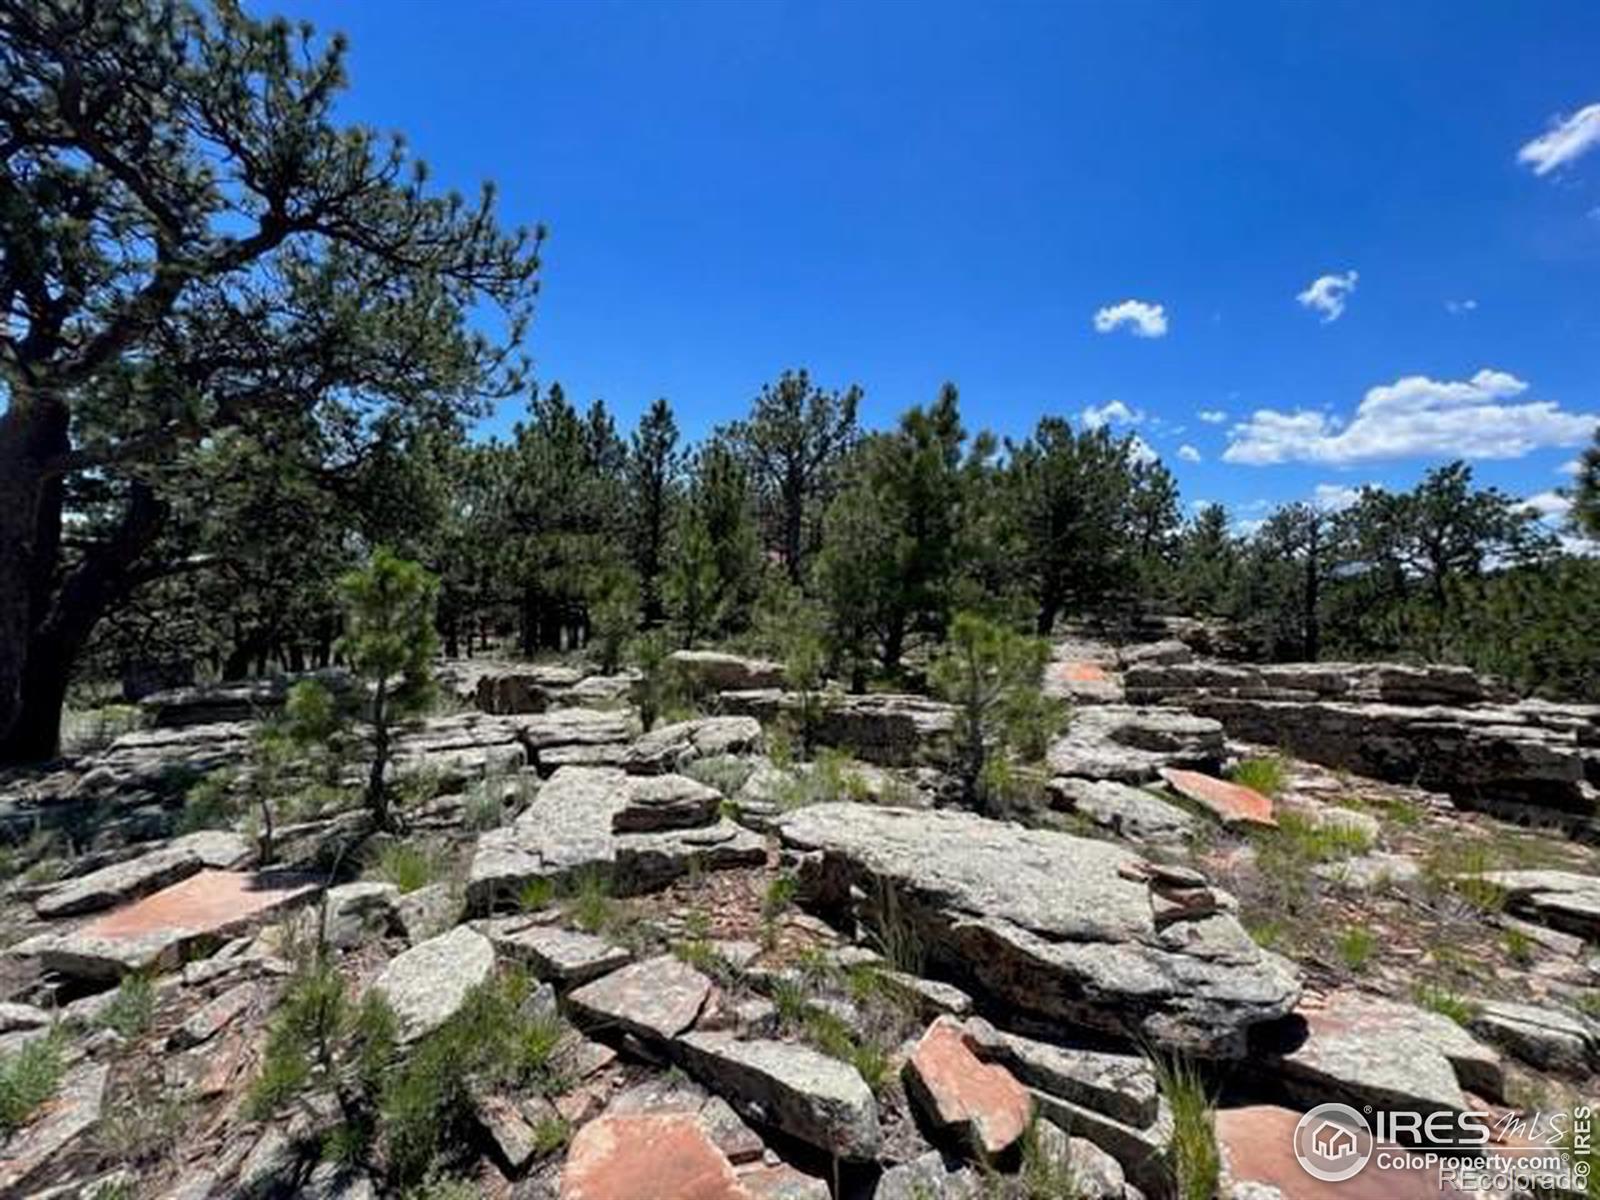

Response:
(0, 638), (1600, 1200)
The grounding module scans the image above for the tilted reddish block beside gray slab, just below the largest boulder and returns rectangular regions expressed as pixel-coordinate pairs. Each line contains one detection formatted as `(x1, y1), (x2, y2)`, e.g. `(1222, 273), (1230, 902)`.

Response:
(906, 1016), (1034, 1157)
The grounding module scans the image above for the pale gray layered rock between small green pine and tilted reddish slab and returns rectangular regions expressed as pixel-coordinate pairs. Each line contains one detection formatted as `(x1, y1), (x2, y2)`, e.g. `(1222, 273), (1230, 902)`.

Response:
(1046, 704), (1226, 784)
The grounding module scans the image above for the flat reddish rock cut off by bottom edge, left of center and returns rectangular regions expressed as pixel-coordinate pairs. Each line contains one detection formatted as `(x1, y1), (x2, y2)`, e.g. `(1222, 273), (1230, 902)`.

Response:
(562, 1112), (749, 1200)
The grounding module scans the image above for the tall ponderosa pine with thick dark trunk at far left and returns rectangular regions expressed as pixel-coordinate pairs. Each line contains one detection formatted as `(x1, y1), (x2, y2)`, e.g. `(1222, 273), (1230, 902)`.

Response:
(0, 0), (539, 760)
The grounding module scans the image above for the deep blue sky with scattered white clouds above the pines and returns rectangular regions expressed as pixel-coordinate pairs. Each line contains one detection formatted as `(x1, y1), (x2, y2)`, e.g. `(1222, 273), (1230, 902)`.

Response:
(278, 0), (1600, 517)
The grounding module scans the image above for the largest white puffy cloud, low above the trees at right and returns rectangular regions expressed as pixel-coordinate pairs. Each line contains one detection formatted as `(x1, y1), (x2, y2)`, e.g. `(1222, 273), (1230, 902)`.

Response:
(1222, 370), (1600, 466)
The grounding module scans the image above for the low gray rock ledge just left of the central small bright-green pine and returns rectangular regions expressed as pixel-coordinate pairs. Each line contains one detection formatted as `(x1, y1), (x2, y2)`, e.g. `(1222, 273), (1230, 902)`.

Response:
(718, 688), (955, 766)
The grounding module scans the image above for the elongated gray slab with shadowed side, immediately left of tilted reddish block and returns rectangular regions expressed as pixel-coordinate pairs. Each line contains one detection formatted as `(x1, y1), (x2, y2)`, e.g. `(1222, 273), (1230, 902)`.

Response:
(675, 1034), (883, 1160)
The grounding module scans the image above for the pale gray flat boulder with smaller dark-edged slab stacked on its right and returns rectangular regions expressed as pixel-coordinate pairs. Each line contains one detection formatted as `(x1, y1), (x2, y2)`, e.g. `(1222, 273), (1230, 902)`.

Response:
(467, 766), (766, 912)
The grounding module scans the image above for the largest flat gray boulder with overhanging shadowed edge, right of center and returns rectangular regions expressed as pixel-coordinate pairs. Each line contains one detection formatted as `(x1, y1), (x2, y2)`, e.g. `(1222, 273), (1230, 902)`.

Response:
(779, 803), (1301, 1054)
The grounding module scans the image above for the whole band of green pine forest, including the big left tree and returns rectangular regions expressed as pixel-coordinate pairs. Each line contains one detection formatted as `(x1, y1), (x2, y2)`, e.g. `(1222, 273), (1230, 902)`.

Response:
(0, 0), (1600, 762)
